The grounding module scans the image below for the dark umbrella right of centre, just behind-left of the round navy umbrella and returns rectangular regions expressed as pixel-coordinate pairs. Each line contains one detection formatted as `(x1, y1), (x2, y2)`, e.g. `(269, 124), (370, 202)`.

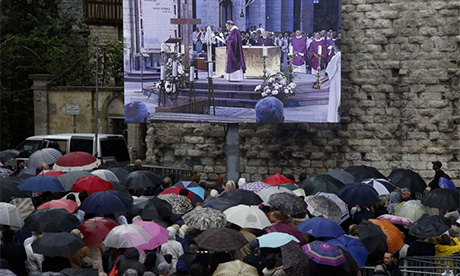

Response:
(300, 174), (345, 195)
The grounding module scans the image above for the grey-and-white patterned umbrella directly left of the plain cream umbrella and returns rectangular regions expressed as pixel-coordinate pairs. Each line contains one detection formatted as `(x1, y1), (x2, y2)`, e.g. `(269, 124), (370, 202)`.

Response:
(182, 206), (227, 230)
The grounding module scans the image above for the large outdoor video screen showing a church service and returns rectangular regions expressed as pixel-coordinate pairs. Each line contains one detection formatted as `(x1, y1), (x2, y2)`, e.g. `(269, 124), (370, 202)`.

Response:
(123, 0), (341, 123)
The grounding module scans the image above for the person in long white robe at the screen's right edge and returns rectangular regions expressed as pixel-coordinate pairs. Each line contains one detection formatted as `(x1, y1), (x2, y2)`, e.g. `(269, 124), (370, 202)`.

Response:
(326, 40), (342, 123)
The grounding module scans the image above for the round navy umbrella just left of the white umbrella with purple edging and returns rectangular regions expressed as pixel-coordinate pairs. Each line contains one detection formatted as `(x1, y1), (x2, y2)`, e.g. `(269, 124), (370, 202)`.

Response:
(339, 182), (379, 206)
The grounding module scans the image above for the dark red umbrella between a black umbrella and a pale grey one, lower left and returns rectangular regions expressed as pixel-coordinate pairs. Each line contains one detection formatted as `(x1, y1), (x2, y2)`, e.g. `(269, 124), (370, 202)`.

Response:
(78, 217), (118, 245)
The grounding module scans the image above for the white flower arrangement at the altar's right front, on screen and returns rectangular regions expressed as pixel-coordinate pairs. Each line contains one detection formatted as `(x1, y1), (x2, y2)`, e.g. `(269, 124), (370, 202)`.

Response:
(254, 74), (297, 98)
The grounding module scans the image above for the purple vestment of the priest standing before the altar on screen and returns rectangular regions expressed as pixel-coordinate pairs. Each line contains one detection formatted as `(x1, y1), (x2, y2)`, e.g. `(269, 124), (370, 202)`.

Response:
(225, 28), (246, 74)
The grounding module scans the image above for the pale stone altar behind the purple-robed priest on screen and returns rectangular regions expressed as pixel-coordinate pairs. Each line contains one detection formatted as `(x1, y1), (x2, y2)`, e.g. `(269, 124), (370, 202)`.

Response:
(216, 46), (281, 78)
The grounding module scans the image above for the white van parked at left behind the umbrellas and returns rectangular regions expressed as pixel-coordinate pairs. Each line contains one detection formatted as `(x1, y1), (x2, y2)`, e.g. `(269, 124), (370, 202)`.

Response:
(16, 133), (131, 167)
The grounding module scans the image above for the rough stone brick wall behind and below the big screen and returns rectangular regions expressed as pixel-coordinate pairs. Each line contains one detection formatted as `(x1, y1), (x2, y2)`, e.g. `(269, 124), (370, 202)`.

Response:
(147, 0), (460, 185)
